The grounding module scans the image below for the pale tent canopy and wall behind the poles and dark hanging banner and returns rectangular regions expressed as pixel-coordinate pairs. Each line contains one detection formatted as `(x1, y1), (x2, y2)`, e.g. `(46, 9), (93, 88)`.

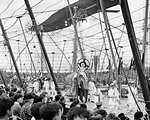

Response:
(0, 0), (150, 72)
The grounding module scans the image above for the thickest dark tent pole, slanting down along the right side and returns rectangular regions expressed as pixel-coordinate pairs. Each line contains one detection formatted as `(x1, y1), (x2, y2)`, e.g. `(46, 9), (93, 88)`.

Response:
(120, 0), (150, 114)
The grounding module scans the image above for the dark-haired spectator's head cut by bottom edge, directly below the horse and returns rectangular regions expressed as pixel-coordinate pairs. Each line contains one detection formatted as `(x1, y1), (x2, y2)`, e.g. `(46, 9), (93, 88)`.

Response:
(67, 107), (89, 120)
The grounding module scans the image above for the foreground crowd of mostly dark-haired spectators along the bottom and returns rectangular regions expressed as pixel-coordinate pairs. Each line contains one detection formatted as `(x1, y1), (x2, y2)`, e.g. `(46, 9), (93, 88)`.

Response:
(0, 76), (146, 120)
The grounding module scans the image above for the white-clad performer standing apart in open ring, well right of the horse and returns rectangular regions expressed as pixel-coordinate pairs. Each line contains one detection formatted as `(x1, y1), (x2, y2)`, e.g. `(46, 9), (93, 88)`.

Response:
(108, 83), (119, 113)
